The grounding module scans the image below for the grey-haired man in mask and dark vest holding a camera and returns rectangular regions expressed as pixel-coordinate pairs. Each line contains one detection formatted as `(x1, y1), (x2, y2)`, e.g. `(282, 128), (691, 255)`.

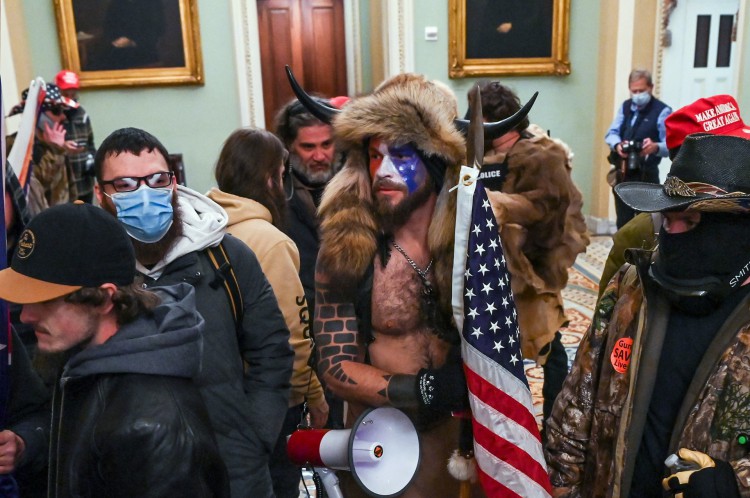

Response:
(604, 69), (672, 229)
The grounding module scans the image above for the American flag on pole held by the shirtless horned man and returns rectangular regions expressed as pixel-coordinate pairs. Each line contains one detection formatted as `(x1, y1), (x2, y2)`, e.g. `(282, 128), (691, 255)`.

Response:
(453, 167), (551, 498)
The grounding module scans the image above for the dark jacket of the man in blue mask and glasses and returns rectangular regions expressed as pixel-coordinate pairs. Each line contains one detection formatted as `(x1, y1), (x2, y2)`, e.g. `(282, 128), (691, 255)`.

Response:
(145, 235), (294, 498)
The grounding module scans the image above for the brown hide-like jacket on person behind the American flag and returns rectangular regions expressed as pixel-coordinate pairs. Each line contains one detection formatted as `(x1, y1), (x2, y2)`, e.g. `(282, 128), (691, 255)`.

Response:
(484, 128), (589, 359)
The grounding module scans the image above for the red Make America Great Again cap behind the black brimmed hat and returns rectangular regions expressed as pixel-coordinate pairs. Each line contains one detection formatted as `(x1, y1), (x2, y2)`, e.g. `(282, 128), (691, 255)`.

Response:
(664, 95), (750, 149)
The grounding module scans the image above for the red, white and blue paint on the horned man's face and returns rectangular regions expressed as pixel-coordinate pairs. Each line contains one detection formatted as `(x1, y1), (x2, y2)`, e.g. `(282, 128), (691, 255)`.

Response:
(370, 139), (427, 194)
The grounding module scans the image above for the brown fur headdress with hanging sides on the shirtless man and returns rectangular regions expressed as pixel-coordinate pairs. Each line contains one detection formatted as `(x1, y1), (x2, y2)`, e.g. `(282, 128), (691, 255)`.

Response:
(318, 74), (465, 309)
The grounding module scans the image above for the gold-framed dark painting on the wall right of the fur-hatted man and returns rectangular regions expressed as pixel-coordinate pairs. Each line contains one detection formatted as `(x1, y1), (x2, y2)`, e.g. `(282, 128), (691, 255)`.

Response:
(448, 0), (570, 78)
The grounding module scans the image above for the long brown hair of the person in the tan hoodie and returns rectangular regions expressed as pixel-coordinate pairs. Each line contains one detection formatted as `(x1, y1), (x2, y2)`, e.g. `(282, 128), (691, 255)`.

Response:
(215, 128), (287, 228)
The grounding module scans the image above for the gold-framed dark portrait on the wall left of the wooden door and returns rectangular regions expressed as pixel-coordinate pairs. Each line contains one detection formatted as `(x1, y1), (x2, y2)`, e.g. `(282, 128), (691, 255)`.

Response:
(54, 0), (203, 88)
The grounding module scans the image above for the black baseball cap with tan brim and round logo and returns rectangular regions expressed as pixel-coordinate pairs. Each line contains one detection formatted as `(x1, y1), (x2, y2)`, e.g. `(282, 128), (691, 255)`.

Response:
(0, 201), (135, 304)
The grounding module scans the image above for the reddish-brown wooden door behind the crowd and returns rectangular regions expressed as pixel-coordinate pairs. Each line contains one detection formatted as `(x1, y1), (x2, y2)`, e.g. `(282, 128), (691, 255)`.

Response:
(257, 0), (347, 129)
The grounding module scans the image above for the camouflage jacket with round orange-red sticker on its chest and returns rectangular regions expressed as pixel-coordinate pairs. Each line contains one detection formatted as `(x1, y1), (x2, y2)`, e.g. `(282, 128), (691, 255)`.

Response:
(545, 250), (750, 498)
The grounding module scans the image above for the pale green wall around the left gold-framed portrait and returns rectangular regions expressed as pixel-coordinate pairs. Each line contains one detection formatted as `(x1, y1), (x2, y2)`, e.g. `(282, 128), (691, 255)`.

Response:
(23, 0), (240, 192)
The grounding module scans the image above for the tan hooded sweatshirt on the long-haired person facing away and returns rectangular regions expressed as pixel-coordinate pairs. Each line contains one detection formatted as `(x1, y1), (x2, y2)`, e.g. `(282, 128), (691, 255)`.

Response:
(207, 188), (325, 407)
